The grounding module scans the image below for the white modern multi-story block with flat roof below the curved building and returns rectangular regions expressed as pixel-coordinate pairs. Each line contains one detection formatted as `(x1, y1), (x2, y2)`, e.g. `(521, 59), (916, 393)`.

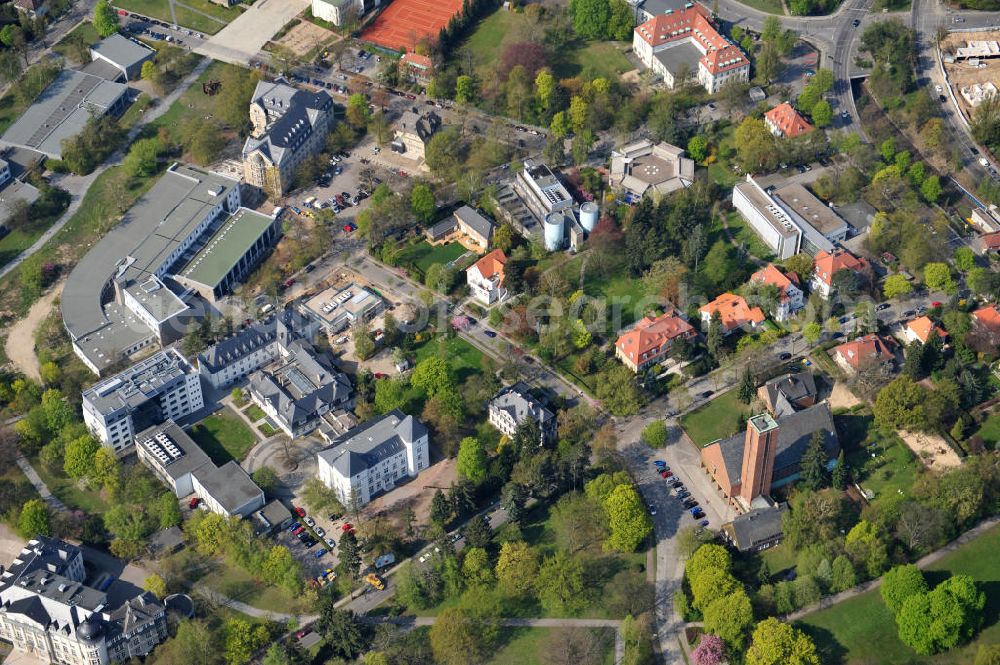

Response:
(82, 348), (205, 455)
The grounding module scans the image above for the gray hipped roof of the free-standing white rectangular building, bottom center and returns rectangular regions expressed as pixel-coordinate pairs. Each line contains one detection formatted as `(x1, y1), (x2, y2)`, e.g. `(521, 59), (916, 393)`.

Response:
(319, 409), (427, 478)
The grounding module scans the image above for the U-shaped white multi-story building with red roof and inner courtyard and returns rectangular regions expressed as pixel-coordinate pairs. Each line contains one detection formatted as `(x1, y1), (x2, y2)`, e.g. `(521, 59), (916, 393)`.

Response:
(632, 4), (750, 93)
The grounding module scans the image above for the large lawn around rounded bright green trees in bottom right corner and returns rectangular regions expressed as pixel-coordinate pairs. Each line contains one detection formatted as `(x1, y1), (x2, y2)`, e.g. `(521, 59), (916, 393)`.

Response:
(798, 527), (1000, 665)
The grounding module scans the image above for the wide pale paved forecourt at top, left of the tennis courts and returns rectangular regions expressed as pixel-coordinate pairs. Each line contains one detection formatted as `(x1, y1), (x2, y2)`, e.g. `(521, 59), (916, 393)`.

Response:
(195, 0), (309, 65)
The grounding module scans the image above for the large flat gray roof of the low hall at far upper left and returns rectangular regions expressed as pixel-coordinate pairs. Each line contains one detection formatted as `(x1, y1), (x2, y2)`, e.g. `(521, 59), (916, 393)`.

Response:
(3, 69), (128, 158)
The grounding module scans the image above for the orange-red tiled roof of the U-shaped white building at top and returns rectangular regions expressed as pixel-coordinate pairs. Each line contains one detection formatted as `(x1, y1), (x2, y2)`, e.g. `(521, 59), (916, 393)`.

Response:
(635, 3), (750, 74)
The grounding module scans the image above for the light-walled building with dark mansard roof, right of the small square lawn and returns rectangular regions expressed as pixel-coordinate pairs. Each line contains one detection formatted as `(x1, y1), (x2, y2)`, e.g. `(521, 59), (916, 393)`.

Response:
(249, 339), (354, 438)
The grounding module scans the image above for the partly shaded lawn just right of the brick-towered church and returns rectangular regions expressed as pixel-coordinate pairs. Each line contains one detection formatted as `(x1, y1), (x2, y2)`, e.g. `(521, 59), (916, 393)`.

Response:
(835, 412), (923, 499)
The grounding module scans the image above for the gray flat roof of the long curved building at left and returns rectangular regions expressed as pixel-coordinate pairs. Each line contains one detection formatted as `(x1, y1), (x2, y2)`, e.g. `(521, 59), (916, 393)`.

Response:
(60, 164), (238, 366)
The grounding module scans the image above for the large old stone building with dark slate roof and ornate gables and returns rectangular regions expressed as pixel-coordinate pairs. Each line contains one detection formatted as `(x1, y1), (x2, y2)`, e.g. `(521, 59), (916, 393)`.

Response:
(243, 78), (333, 196)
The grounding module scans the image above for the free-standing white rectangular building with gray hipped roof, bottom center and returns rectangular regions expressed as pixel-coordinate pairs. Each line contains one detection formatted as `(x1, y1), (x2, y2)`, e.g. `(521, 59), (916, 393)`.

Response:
(316, 409), (430, 507)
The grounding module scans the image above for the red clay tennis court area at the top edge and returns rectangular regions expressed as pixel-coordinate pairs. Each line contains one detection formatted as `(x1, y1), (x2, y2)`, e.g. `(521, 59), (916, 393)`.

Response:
(361, 0), (462, 51)
